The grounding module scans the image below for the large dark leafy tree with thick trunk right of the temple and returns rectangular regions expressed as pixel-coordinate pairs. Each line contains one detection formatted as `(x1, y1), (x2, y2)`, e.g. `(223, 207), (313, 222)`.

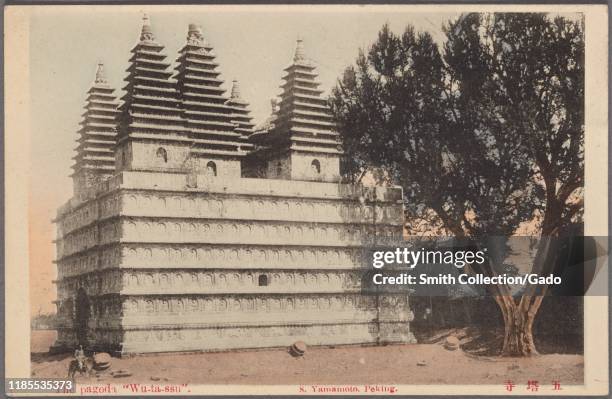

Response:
(330, 13), (584, 355)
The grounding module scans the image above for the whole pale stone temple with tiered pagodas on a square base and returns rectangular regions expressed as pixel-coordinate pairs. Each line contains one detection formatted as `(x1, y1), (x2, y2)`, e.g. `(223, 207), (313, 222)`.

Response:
(54, 17), (414, 354)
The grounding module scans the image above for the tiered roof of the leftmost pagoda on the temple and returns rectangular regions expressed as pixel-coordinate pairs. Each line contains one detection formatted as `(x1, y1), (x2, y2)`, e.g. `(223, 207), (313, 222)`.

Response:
(72, 63), (119, 176)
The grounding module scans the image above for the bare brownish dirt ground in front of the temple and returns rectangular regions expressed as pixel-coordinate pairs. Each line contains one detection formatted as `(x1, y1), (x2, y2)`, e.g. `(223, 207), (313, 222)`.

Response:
(32, 331), (584, 385)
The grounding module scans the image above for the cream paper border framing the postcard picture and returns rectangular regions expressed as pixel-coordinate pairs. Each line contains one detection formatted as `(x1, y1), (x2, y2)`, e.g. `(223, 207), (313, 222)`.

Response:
(4, 4), (609, 395)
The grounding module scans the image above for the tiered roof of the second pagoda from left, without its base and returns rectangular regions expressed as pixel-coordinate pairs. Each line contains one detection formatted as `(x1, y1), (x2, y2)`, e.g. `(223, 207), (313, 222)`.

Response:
(119, 15), (189, 145)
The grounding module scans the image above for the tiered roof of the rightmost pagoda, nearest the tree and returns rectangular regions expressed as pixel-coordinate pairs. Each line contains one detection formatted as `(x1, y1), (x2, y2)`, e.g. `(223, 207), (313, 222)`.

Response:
(253, 39), (342, 155)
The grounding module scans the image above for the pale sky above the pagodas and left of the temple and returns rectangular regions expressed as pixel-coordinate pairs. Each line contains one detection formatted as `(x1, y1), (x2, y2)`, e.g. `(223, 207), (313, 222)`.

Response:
(29, 6), (457, 310)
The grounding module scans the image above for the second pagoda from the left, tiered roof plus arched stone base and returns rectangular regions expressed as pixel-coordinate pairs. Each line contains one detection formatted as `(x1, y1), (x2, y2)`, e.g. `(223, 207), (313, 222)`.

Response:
(116, 15), (191, 171)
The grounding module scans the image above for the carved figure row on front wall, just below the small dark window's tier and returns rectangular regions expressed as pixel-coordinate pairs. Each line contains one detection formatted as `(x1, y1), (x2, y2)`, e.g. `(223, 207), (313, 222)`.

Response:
(117, 293), (408, 316)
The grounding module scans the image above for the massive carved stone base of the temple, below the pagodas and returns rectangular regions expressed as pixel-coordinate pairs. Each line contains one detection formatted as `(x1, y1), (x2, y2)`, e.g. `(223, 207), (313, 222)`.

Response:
(57, 172), (413, 353)
